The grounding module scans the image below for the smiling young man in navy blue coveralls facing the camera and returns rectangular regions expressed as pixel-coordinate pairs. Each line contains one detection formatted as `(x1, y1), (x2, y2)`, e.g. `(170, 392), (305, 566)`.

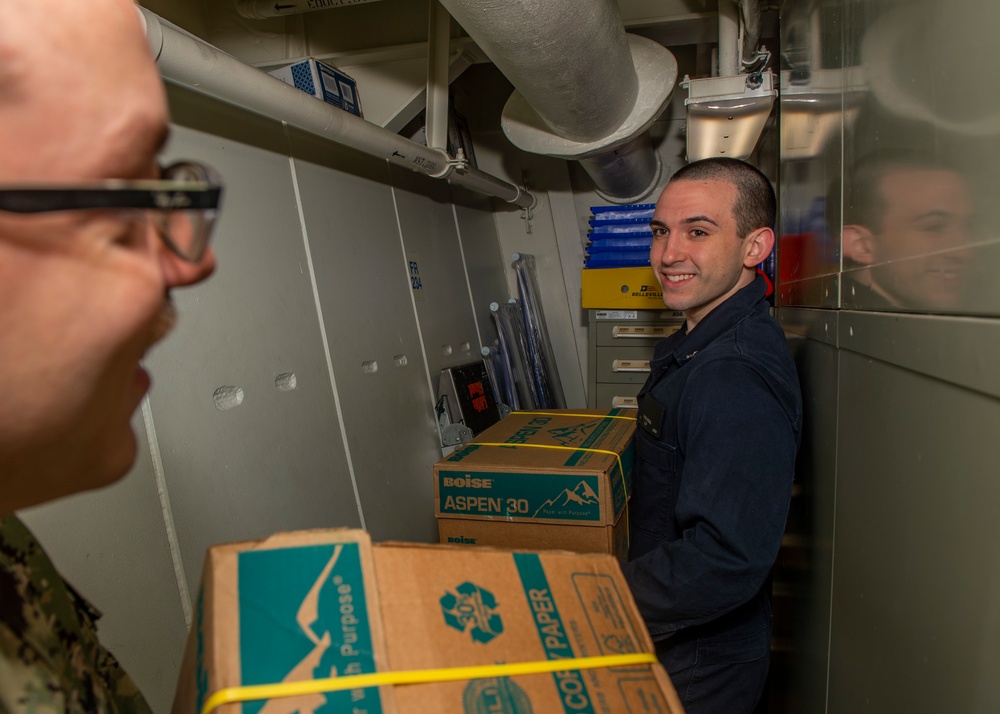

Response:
(624, 158), (802, 714)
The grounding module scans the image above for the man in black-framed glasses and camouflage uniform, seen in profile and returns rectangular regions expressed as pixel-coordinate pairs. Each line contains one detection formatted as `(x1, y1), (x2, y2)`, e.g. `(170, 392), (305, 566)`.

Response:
(0, 0), (221, 712)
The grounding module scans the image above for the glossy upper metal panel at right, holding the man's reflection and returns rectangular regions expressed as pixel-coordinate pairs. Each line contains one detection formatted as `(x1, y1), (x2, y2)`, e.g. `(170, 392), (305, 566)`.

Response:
(780, 0), (1000, 315)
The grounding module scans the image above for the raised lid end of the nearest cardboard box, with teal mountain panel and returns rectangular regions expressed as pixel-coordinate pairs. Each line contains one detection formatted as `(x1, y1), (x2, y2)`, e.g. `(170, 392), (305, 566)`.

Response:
(173, 530), (395, 714)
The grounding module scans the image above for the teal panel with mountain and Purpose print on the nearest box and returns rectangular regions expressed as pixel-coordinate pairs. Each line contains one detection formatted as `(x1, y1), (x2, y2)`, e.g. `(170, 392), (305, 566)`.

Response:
(237, 543), (382, 714)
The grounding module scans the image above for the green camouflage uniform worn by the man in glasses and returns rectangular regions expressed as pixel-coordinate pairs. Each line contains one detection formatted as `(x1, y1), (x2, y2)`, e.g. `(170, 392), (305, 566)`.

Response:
(0, 516), (150, 714)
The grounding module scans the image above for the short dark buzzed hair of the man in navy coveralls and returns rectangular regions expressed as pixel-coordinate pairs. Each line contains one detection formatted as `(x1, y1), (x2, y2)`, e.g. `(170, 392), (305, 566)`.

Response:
(668, 156), (778, 238)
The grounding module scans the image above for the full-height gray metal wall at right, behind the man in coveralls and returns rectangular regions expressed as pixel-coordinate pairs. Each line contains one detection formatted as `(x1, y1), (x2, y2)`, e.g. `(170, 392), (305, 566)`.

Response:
(778, 0), (1000, 714)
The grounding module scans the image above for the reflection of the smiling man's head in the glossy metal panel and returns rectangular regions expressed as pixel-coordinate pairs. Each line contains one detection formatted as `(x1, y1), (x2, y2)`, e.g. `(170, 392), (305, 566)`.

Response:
(843, 152), (973, 310)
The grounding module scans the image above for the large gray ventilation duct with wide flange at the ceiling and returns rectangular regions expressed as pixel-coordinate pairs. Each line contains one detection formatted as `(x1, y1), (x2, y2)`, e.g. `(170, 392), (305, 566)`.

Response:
(440, 0), (677, 203)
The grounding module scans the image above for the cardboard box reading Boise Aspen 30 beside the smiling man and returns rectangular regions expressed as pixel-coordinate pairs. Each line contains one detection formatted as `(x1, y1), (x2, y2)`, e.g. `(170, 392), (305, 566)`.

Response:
(434, 409), (635, 559)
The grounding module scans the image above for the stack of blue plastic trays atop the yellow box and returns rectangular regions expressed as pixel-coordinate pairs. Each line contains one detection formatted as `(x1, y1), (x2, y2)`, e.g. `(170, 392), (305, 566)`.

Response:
(584, 203), (656, 268)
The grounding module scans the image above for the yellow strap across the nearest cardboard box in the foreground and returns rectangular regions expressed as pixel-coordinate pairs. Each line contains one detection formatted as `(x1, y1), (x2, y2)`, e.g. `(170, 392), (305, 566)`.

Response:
(201, 652), (658, 714)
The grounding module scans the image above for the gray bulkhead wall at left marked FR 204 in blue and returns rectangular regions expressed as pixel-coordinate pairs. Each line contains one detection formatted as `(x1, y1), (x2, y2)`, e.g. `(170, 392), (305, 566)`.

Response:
(22, 87), (520, 711)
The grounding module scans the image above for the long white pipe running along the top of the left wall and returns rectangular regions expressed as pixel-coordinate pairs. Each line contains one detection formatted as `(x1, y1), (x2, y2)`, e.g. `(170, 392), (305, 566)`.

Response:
(138, 7), (535, 209)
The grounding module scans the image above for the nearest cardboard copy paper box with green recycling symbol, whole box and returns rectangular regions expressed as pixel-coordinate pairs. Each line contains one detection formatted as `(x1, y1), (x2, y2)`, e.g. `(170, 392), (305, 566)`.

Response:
(173, 530), (682, 714)
